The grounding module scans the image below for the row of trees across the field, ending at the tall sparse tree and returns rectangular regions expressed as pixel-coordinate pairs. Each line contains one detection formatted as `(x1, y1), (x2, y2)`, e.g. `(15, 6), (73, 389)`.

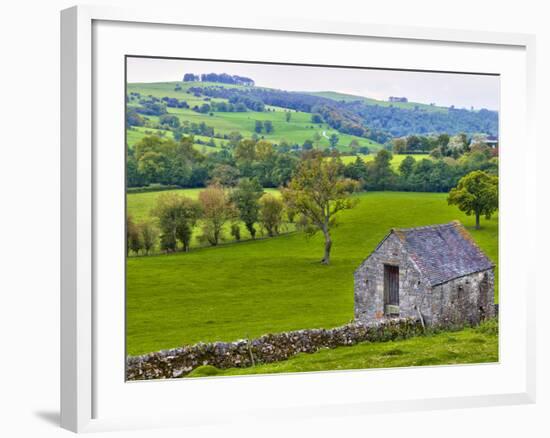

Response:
(127, 153), (358, 264)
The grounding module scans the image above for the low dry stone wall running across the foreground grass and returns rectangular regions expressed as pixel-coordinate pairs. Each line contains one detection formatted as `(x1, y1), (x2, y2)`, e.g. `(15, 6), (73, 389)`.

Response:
(126, 318), (423, 380)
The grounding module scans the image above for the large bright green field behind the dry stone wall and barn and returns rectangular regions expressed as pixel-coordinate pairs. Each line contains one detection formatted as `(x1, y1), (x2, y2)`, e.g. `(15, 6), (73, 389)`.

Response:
(126, 190), (498, 356)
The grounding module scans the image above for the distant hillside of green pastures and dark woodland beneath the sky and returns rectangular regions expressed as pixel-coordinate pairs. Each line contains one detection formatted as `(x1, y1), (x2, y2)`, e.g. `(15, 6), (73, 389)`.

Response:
(127, 81), (498, 152)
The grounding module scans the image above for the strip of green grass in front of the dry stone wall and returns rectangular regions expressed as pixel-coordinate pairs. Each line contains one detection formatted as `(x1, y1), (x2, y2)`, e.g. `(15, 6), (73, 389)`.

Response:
(188, 321), (498, 377)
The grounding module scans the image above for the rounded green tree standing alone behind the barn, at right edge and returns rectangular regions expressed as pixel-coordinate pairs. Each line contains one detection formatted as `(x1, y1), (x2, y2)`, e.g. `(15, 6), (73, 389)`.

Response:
(447, 170), (498, 230)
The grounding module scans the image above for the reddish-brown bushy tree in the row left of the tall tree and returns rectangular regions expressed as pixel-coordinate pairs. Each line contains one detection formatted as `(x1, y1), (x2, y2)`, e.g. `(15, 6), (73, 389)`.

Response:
(199, 185), (236, 246)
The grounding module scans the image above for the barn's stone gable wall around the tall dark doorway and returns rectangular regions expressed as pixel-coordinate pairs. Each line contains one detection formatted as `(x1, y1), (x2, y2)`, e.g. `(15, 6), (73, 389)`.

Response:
(354, 234), (432, 321)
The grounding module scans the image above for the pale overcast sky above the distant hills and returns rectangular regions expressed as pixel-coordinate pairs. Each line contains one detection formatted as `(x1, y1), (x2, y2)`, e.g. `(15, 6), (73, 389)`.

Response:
(127, 58), (499, 110)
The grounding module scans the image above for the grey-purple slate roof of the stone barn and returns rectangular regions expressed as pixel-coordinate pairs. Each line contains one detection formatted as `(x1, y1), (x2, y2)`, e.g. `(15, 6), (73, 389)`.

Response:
(390, 221), (494, 286)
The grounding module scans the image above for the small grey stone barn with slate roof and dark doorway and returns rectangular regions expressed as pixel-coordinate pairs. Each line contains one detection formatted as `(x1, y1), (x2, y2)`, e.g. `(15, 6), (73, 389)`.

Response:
(354, 221), (495, 325)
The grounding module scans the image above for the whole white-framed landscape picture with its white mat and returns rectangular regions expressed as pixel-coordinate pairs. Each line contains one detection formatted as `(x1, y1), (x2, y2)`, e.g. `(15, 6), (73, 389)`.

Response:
(61, 7), (536, 431)
